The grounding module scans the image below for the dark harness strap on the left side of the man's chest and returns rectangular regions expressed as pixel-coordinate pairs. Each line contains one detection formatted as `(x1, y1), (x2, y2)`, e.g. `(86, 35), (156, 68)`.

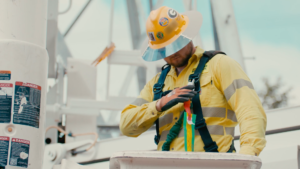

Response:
(153, 64), (171, 145)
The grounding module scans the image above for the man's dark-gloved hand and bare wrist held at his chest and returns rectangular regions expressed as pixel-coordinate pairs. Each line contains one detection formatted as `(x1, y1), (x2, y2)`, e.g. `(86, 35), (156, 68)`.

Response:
(156, 85), (197, 111)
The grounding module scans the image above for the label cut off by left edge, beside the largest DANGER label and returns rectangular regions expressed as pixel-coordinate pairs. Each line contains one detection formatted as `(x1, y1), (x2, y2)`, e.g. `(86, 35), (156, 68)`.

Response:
(0, 83), (13, 123)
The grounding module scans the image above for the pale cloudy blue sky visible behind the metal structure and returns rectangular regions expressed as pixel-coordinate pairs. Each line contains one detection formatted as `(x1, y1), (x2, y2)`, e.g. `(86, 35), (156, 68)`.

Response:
(58, 0), (300, 105)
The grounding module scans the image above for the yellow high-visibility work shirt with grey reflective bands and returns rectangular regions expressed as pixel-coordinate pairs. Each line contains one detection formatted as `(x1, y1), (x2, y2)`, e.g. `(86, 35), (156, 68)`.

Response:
(120, 47), (267, 155)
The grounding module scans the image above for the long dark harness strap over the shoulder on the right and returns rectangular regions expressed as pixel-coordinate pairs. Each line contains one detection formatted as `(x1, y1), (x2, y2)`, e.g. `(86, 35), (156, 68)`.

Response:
(189, 51), (225, 152)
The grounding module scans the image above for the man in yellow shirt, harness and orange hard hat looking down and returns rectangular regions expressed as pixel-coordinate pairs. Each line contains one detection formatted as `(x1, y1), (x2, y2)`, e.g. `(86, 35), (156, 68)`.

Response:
(120, 6), (267, 156)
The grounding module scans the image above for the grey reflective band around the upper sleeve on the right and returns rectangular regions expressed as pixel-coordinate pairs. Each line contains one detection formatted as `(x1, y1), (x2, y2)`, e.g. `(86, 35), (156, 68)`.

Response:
(224, 79), (254, 101)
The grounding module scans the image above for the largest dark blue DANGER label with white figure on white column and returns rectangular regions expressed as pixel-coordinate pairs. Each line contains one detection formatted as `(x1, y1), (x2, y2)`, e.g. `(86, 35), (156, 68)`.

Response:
(13, 82), (41, 128)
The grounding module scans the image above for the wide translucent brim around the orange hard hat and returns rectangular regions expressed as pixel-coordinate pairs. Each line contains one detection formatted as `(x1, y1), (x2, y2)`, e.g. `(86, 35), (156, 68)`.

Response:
(142, 11), (203, 62)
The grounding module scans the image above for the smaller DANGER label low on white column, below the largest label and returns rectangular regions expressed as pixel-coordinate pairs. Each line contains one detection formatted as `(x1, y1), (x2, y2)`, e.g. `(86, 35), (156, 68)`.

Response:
(9, 138), (30, 168)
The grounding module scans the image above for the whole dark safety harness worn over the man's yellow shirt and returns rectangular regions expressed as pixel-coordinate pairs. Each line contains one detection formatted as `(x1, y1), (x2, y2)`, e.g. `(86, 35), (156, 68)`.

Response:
(153, 51), (235, 152)
